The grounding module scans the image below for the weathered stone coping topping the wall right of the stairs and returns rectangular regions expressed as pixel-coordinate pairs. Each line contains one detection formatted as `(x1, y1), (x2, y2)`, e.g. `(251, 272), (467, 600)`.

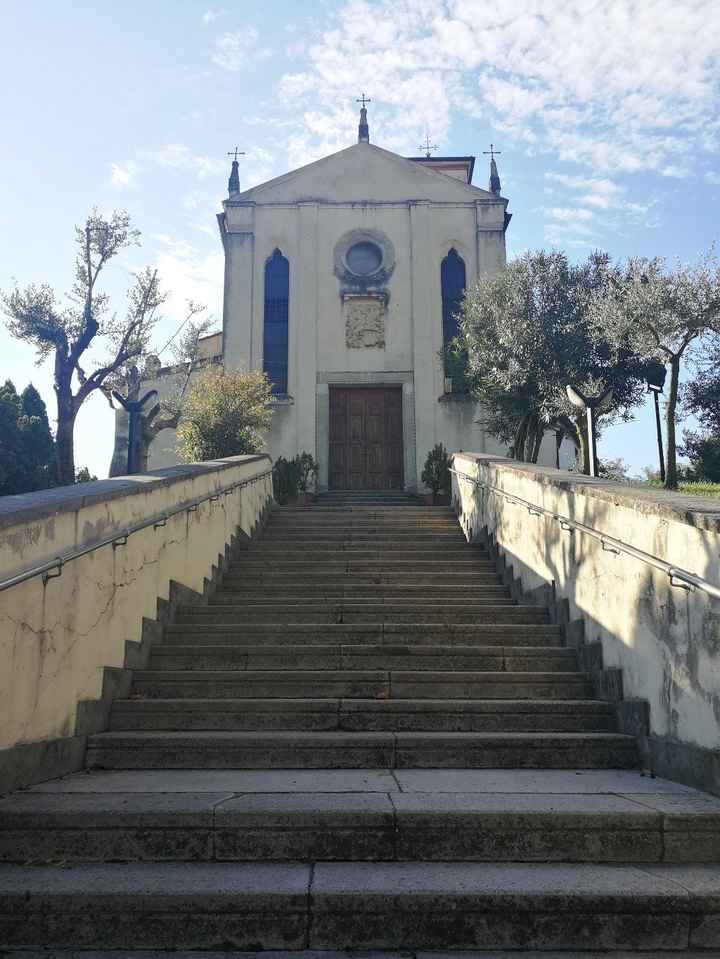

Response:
(456, 451), (720, 533)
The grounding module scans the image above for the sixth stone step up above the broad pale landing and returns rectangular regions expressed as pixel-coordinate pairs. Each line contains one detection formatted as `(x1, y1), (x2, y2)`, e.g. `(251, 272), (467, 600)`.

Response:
(176, 599), (547, 626)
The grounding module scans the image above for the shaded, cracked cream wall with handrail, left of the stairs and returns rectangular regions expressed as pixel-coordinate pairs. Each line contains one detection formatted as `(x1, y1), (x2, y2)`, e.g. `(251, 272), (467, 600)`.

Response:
(0, 455), (272, 792)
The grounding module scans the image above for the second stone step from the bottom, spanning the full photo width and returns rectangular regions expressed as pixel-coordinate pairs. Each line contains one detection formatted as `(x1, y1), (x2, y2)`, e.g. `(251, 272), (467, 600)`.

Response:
(5, 791), (720, 864)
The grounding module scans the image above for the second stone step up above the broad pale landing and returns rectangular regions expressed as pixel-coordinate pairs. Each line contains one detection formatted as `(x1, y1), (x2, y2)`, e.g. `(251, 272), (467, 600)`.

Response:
(110, 698), (617, 733)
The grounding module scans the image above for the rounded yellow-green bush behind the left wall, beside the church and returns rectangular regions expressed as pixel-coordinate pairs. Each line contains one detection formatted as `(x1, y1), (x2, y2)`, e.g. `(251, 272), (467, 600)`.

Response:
(178, 367), (272, 463)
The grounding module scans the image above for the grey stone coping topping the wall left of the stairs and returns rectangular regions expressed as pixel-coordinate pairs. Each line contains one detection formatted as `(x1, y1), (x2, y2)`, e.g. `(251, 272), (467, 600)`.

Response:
(0, 453), (271, 531)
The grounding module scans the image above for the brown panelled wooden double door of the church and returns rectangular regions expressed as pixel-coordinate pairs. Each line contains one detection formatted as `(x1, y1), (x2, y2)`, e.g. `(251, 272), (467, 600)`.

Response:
(329, 386), (403, 489)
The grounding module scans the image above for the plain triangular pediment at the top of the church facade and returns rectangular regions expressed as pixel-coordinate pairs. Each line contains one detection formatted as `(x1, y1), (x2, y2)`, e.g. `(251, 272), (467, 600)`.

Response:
(226, 143), (504, 204)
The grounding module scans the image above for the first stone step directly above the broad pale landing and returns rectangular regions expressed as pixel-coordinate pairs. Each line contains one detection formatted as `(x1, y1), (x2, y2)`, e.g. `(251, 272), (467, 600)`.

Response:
(87, 730), (638, 769)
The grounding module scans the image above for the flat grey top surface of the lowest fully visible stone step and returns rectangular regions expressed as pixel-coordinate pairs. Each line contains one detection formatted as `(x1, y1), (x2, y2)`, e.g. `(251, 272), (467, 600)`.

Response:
(0, 862), (720, 900)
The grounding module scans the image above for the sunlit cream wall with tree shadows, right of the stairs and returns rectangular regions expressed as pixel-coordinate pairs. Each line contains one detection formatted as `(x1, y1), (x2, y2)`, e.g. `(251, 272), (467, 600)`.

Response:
(453, 453), (720, 794)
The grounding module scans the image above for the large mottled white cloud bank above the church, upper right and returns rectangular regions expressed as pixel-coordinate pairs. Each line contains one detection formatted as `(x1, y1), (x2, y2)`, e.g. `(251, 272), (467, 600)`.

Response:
(272, 0), (720, 183)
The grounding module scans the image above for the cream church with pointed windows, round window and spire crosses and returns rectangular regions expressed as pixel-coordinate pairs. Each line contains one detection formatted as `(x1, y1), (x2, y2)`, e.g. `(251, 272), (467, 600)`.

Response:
(141, 106), (554, 489)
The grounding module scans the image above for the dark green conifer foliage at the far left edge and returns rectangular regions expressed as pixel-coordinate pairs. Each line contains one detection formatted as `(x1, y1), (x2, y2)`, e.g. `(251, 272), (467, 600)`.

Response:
(0, 380), (55, 496)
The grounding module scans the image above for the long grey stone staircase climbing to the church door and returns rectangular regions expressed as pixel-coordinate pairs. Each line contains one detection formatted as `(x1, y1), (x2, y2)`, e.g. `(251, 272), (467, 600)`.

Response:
(0, 494), (720, 959)
